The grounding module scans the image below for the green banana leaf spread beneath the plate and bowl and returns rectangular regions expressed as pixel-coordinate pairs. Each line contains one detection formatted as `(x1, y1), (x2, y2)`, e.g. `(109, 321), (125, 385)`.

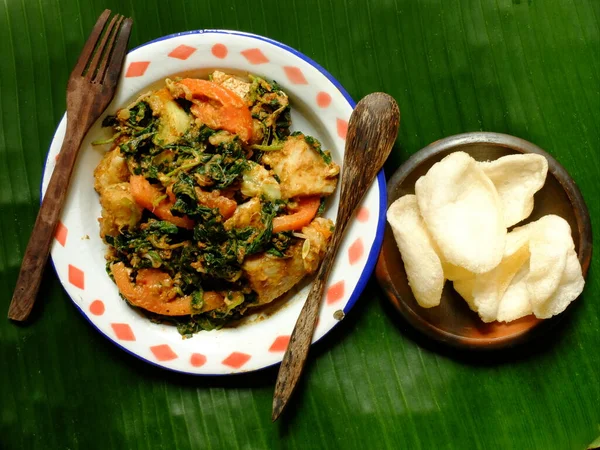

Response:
(0, 0), (600, 450)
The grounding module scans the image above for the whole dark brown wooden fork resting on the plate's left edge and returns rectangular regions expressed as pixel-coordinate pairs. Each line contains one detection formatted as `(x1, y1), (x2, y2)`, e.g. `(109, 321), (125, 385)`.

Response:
(8, 9), (133, 321)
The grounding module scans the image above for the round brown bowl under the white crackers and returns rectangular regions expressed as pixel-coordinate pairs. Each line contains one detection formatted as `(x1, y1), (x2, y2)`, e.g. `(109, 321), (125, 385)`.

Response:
(375, 132), (592, 349)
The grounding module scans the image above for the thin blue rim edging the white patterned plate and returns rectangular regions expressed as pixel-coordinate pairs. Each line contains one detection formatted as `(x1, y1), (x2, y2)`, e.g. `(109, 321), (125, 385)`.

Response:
(40, 29), (387, 377)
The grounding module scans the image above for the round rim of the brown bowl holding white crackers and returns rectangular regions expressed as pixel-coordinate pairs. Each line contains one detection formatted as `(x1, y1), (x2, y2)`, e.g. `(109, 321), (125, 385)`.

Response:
(376, 131), (593, 350)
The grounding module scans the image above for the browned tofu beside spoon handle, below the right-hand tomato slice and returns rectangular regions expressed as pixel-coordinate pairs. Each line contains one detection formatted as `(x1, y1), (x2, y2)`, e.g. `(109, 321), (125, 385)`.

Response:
(242, 218), (333, 305)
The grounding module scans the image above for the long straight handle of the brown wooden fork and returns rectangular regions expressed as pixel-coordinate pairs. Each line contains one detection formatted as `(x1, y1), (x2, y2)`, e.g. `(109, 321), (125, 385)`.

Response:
(8, 123), (87, 321)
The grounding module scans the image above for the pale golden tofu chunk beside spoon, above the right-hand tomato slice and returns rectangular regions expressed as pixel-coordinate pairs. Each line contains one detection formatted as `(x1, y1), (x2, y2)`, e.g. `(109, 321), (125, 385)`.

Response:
(262, 134), (340, 199)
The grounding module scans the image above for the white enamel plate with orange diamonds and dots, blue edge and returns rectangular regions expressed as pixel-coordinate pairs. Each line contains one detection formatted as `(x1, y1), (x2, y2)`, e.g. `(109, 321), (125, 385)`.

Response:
(42, 30), (386, 375)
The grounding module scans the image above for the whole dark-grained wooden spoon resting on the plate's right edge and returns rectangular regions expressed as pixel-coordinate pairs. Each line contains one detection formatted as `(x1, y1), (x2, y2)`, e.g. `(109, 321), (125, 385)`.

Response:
(272, 92), (400, 421)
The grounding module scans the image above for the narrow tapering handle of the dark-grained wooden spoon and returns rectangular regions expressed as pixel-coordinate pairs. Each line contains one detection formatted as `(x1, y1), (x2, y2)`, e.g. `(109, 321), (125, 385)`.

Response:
(272, 213), (348, 422)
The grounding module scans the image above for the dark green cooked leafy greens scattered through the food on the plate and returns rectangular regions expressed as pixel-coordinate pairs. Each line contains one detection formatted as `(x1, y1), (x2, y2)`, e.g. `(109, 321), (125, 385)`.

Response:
(97, 76), (331, 336)
